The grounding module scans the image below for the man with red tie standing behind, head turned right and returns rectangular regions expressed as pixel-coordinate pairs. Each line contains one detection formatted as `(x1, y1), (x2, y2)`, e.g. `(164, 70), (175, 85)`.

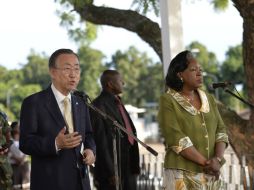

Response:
(90, 70), (140, 190)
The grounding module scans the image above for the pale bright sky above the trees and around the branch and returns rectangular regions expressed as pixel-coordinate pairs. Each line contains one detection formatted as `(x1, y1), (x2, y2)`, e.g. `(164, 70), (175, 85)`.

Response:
(0, 0), (242, 69)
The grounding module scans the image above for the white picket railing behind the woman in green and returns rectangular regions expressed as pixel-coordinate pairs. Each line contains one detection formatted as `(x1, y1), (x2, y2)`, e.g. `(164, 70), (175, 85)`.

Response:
(91, 144), (254, 190)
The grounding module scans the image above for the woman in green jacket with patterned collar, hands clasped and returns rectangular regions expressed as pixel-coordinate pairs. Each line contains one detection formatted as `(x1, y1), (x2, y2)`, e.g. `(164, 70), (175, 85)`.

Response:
(158, 51), (228, 190)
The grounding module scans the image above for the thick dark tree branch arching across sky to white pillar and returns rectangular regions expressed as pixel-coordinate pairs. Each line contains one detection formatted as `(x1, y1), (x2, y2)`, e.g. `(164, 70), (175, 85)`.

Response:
(75, 5), (162, 60)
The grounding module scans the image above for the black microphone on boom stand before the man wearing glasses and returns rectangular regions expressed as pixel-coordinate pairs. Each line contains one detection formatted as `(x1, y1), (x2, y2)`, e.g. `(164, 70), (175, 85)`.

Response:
(73, 91), (158, 190)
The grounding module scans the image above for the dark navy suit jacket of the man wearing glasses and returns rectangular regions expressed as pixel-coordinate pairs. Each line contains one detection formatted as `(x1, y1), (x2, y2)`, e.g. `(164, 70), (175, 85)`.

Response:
(20, 87), (96, 190)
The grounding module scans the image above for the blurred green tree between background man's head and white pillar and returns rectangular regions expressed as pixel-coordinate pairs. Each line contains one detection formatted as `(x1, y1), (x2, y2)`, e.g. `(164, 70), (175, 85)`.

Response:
(106, 47), (163, 107)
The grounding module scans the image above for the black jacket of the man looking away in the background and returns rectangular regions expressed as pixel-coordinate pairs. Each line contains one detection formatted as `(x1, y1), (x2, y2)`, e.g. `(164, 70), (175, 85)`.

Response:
(90, 91), (140, 187)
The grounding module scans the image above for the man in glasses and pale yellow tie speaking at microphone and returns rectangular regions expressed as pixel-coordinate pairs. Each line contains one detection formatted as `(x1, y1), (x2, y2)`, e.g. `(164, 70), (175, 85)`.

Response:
(20, 49), (96, 190)
